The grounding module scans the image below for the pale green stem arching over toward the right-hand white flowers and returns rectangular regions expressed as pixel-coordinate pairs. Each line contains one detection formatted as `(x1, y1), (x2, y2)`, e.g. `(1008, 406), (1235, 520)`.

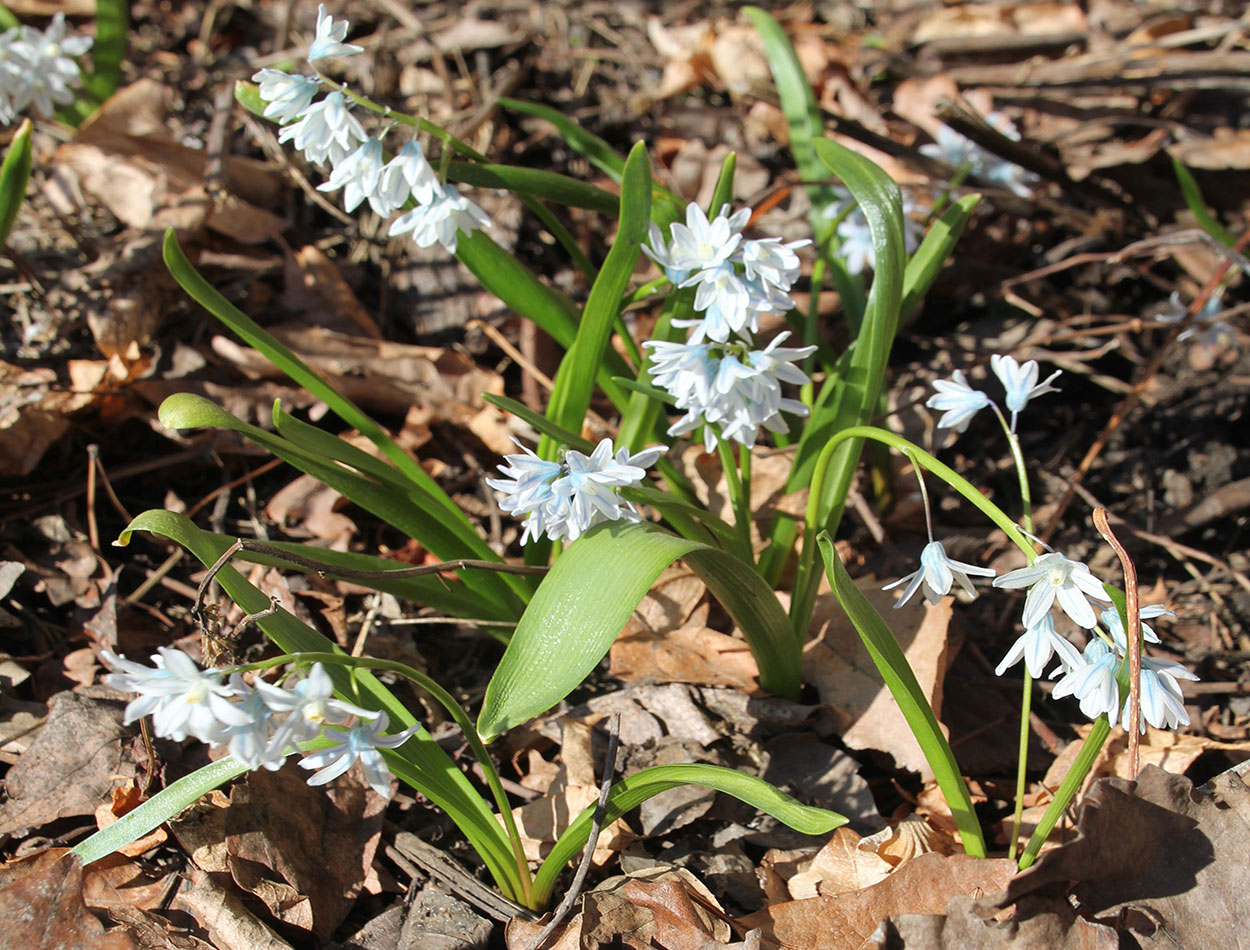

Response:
(791, 425), (1038, 640)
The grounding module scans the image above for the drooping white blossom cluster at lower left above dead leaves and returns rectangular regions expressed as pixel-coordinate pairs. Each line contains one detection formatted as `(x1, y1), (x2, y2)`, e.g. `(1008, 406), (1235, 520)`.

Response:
(101, 646), (418, 798)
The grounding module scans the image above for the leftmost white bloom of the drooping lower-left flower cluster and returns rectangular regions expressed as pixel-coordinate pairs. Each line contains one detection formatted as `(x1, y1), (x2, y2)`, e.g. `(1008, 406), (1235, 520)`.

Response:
(100, 646), (251, 745)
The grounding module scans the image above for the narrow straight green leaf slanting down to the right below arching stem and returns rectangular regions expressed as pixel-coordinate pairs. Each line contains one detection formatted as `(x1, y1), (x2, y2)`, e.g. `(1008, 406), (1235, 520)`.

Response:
(818, 531), (985, 858)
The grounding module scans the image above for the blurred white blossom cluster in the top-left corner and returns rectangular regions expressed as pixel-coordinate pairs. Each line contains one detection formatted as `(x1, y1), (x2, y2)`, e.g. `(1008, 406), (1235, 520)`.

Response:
(0, 14), (91, 125)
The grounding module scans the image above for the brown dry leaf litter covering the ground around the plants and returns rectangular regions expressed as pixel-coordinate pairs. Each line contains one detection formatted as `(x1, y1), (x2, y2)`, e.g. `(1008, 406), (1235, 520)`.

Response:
(0, 0), (1250, 950)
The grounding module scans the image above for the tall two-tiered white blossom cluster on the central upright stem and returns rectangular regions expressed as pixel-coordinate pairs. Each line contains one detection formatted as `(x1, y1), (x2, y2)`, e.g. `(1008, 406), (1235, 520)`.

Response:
(643, 204), (816, 451)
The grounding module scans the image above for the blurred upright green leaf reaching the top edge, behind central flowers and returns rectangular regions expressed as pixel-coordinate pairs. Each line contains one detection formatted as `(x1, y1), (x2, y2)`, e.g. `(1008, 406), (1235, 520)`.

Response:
(744, 6), (836, 237)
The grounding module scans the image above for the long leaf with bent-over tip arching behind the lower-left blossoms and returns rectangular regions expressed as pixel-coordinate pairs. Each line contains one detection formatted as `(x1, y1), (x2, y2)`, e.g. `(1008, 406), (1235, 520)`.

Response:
(116, 511), (521, 900)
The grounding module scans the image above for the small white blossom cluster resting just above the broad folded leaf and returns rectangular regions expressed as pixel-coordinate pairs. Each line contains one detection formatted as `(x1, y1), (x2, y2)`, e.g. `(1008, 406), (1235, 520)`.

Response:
(486, 439), (664, 544)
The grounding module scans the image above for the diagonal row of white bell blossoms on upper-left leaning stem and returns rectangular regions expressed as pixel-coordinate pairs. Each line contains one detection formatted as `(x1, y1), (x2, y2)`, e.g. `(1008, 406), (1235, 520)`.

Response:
(253, 4), (490, 254)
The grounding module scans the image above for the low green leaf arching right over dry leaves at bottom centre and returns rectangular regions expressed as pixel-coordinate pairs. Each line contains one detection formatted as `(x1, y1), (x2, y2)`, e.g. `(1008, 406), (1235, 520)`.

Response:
(534, 764), (849, 905)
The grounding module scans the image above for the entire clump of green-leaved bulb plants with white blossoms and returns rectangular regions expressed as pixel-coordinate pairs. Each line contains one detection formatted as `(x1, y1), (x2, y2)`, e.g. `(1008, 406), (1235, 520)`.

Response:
(76, 5), (1193, 910)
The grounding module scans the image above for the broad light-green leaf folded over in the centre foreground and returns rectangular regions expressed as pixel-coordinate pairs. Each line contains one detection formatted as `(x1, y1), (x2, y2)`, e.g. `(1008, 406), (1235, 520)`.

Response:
(478, 521), (800, 740)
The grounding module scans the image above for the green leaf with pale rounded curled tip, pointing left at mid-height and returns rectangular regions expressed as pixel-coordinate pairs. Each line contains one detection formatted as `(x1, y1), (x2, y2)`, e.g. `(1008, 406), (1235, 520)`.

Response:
(158, 393), (520, 619)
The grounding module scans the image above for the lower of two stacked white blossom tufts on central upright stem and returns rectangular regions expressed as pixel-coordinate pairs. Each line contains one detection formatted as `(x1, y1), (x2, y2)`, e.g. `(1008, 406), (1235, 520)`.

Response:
(643, 333), (816, 451)
